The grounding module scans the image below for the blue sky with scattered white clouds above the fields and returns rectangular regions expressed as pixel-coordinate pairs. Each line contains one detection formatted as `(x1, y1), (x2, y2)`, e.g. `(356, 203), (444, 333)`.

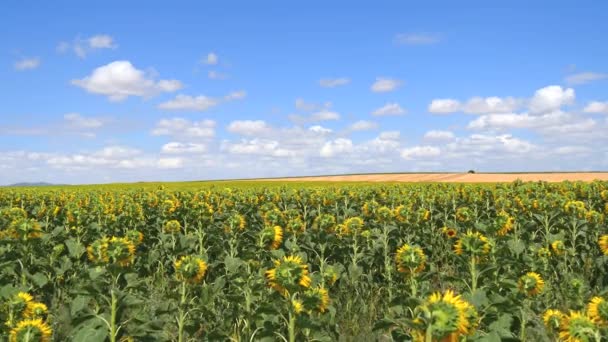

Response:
(0, 1), (608, 184)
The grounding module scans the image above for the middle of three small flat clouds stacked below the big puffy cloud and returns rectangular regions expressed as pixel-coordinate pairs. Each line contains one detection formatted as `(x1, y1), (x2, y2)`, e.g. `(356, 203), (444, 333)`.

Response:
(152, 118), (215, 140)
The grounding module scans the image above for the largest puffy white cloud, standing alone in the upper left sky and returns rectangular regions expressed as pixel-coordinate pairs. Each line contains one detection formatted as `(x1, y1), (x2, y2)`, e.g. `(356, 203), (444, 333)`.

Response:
(72, 61), (182, 101)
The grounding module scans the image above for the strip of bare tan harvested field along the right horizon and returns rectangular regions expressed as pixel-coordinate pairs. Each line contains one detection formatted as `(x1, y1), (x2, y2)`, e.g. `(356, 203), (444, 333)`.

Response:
(264, 172), (608, 183)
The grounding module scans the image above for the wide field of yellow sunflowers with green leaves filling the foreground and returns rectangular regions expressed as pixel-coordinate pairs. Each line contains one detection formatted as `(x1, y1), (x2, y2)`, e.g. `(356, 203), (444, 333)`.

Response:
(0, 181), (608, 342)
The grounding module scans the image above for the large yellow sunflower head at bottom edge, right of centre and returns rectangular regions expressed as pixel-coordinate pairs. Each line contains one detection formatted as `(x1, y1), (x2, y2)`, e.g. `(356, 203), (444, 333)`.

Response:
(425, 290), (470, 340)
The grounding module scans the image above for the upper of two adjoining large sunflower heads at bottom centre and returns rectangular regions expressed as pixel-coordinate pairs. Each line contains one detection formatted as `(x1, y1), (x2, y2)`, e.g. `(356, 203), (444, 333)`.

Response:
(266, 256), (311, 296)
